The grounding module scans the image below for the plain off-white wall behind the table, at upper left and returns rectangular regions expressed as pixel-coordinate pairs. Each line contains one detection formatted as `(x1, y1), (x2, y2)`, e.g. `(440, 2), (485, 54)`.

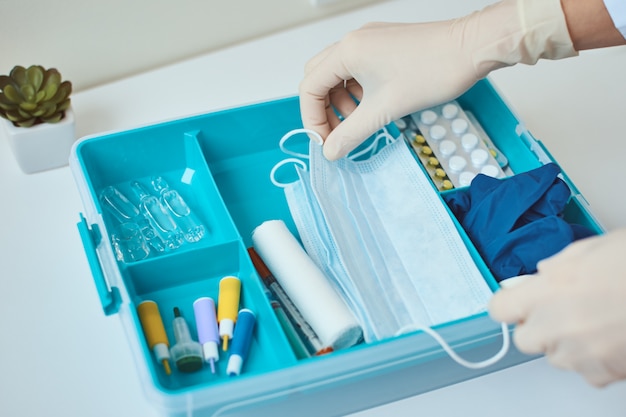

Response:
(0, 0), (381, 91)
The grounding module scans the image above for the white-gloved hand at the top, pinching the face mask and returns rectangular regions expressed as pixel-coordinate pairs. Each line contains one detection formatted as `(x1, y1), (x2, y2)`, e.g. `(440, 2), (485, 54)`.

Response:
(300, 0), (576, 160)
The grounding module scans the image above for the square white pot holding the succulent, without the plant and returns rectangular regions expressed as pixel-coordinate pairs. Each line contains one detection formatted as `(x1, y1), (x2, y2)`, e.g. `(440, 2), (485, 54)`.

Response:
(0, 107), (76, 174)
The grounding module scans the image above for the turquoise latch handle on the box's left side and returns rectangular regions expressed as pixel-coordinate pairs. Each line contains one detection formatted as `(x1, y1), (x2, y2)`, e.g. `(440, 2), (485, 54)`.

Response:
(76, 213), (122, 316)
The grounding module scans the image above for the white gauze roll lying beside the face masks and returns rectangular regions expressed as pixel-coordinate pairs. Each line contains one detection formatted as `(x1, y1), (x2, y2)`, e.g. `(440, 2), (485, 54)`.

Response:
(252, 220), (362, 350)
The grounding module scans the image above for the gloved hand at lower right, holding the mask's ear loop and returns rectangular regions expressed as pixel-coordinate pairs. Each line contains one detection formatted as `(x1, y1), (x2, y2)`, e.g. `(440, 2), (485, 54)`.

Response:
(489, 229), (626, 386)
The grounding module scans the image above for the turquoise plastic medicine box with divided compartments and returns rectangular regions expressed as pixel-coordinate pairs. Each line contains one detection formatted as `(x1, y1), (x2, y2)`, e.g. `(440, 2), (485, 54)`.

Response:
(70, 80), (601, 417)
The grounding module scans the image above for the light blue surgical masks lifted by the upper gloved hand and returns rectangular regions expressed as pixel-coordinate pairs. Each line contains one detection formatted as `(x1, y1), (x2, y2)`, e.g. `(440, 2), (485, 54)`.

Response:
(273, 130), (509, 368)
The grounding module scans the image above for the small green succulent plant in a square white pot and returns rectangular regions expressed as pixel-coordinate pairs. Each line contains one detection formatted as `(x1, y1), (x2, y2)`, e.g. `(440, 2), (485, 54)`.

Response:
(0, 65), (75, 174)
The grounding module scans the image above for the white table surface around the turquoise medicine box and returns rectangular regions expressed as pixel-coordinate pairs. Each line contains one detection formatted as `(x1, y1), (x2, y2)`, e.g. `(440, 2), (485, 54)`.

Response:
(0, 0), (626, 417)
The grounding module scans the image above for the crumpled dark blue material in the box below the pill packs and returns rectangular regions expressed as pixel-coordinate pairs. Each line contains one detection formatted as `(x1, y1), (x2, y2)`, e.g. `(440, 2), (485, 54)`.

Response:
(444, 163), (595, 281)
